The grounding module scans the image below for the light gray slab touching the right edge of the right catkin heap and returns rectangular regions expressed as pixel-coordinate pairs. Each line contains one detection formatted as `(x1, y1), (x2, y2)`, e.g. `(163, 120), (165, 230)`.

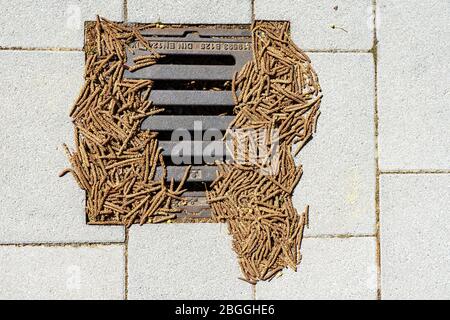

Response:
(293, 53), (375, 235)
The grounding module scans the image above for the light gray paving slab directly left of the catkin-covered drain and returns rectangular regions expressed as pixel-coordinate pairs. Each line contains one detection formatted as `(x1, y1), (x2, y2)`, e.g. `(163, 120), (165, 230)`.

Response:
(0, 50), (124, 243)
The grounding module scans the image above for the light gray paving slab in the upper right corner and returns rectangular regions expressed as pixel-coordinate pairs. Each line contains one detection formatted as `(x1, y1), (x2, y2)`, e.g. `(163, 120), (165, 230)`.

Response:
(377, 0), (450, 170)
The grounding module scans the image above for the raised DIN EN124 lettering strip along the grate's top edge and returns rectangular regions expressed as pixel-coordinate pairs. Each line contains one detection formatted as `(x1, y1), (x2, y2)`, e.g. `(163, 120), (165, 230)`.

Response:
(146, 41), (251, 51)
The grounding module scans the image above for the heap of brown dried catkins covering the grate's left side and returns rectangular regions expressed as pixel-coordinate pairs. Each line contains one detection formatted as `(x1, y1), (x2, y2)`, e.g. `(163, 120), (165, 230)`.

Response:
(61, 18), (188, 226)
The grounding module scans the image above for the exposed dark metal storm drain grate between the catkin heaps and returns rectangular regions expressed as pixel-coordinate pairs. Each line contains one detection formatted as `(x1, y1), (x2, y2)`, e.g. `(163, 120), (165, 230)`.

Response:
(124, 25), (252, 219)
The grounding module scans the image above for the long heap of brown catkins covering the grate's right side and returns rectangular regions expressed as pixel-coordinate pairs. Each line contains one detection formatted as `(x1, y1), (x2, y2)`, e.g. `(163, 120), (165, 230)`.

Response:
(208, 21), (322, 283)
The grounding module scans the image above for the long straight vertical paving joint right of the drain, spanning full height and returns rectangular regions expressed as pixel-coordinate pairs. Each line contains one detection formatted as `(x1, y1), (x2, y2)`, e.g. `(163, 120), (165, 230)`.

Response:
(371, 0), (381, 300)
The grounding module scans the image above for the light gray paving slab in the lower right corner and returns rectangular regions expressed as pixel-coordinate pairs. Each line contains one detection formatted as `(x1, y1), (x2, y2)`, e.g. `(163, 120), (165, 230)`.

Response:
(380, 174), (450, 299)
